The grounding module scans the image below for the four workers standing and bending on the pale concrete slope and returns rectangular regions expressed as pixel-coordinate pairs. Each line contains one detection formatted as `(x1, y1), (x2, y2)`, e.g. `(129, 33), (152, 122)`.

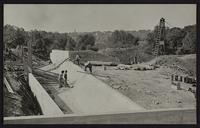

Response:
(58, 54), (92, 88)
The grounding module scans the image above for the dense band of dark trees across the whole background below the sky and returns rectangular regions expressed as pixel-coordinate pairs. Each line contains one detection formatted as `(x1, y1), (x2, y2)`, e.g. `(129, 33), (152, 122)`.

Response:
(3, 25), (196, 60)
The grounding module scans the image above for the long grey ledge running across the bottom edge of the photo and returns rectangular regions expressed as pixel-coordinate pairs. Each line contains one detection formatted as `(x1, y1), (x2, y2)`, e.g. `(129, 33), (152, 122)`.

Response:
(4, 108), (196, 124)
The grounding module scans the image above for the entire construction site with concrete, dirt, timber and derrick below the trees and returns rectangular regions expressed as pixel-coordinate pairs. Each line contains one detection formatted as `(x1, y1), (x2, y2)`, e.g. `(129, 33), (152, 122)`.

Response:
(3, 18), (197, 124)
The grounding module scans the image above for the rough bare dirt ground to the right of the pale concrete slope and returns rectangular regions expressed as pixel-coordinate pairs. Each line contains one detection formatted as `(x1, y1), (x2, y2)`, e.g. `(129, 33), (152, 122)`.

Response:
(93, 55), (196, 109)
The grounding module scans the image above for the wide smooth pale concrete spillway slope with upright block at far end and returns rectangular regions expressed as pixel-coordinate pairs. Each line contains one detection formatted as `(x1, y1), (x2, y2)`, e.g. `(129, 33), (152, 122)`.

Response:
(41, 50), (144, 114)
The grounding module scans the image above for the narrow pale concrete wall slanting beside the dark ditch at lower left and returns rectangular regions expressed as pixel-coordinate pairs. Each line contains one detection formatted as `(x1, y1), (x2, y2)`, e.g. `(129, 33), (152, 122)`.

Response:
(29, 73), (63, 116)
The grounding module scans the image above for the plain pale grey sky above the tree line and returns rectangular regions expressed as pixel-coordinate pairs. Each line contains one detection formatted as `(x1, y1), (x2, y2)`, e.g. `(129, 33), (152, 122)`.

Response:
(4, 4), (196, 32)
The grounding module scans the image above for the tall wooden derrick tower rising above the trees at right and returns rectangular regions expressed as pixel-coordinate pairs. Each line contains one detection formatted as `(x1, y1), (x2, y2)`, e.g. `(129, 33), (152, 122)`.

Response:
(154, 18), (165, 56)
